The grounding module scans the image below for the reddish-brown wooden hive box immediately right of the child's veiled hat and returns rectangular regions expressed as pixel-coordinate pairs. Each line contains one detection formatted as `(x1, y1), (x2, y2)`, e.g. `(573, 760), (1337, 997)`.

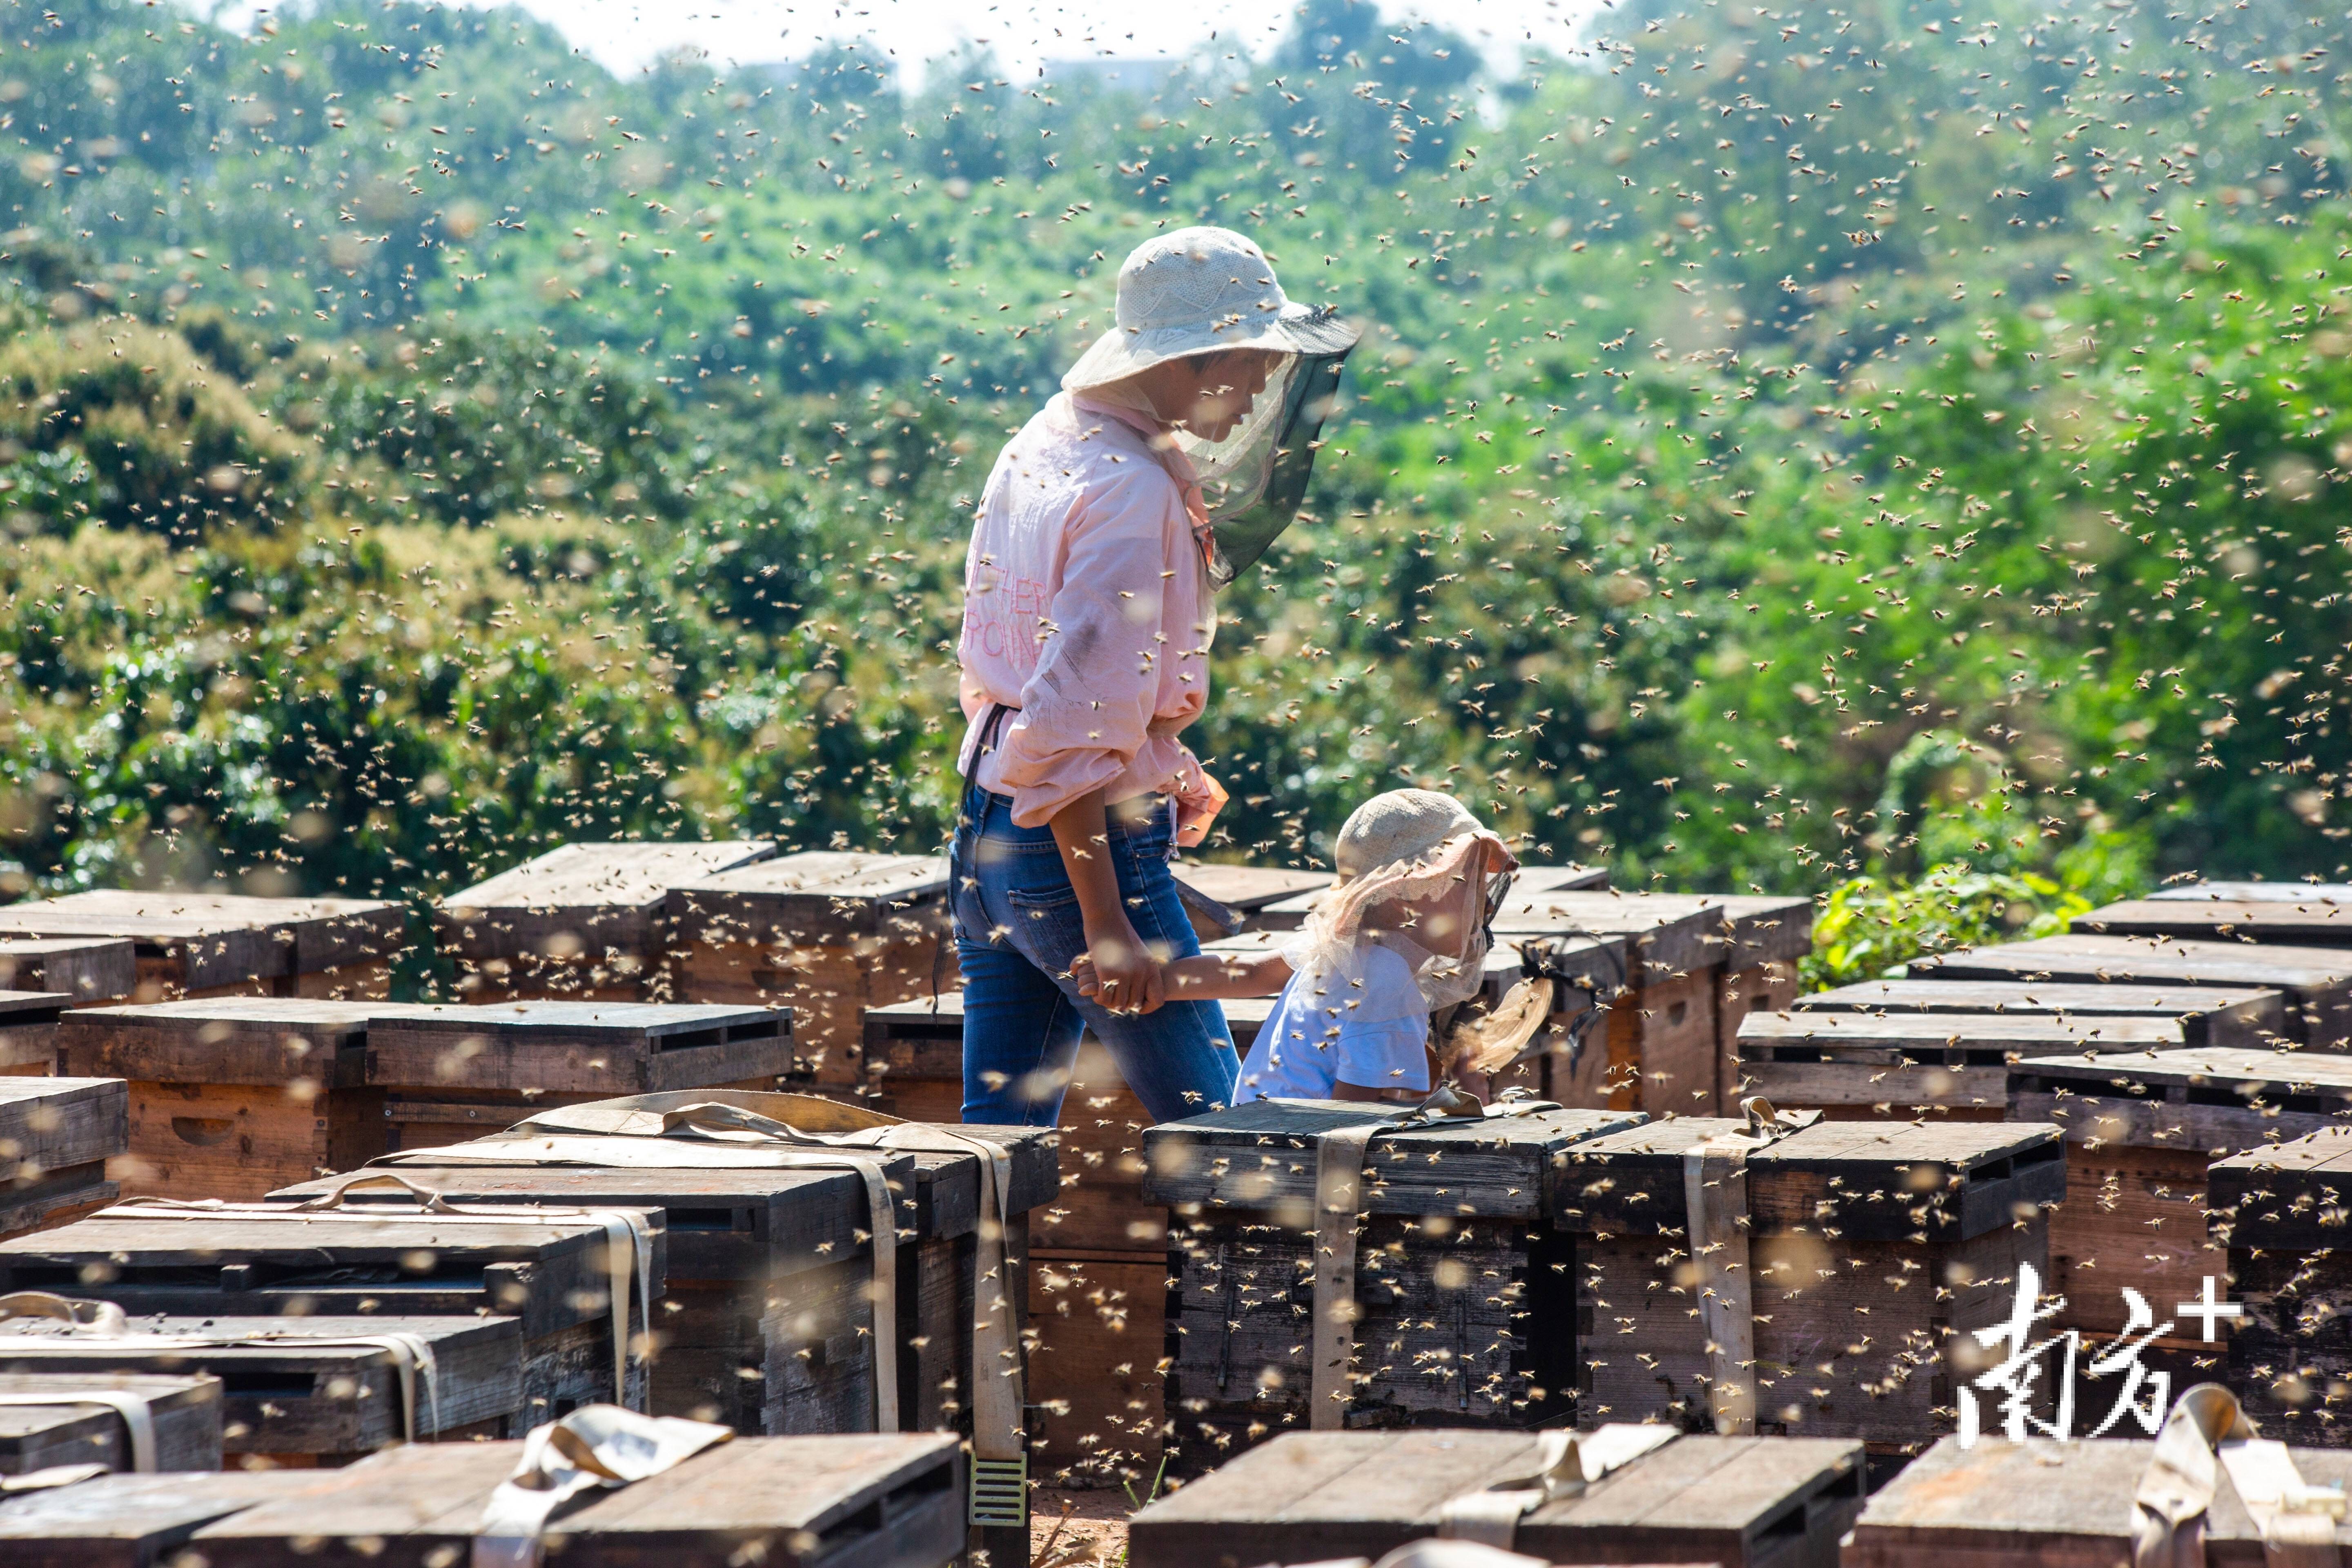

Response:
(1494, 889), (1731, 1117)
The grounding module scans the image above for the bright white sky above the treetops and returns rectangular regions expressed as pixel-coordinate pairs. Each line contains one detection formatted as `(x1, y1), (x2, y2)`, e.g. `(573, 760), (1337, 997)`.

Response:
(234, 0), (1606, 78)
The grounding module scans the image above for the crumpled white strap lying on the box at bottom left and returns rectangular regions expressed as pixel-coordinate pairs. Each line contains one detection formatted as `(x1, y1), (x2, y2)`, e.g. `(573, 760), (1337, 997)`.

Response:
(473, 1406), (734, 1568)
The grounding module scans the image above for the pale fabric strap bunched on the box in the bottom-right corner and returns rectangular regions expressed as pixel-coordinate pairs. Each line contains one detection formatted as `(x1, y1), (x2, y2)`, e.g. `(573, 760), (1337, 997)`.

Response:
(2131, 1382), (2345, 1568)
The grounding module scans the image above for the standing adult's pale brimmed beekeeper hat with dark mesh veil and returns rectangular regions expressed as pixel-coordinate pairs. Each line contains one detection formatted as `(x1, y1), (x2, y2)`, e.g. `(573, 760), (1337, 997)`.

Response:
(1061, 226), (1362, 583)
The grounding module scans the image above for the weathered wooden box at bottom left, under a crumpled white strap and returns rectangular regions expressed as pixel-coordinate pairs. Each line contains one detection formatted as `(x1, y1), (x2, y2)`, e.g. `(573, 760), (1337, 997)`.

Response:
(188, 1434), (964, 1568)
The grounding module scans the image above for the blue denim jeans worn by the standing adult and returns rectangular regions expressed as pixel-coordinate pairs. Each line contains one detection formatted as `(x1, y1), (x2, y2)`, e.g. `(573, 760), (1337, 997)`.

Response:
(950, 788), (1242, 1126)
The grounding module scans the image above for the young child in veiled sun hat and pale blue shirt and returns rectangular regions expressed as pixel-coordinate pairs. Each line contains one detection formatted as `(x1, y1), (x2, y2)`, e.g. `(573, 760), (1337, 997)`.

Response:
(1070, 790), (1517, 1100)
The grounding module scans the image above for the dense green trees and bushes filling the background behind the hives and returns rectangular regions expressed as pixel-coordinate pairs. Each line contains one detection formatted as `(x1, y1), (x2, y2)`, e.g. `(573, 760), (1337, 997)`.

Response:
(0, 0), (2352, 978)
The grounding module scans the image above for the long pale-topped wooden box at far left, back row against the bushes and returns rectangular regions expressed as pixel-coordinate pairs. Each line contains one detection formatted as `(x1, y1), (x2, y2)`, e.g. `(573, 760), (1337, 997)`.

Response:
(0, 891), (407, 1002)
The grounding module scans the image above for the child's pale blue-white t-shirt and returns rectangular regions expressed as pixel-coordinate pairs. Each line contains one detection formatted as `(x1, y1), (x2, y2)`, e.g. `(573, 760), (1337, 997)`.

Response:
(1235, 943), (1430, 1100)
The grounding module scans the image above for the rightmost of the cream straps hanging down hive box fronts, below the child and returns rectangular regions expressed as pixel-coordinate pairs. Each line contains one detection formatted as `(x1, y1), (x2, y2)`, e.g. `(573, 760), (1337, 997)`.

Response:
(1682, 1096), (1820, 1437)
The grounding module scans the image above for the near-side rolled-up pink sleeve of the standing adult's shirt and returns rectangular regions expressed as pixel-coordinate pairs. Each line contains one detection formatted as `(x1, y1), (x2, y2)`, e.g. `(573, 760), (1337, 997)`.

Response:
(997, 463), (1195, 828)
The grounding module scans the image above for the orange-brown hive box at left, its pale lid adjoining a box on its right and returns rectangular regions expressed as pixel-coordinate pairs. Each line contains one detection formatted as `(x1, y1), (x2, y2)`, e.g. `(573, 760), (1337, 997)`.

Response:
(59, 997), (430, 1201)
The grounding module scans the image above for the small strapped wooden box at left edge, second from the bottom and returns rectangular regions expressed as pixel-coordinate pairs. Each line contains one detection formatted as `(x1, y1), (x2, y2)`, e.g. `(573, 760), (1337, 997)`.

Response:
(0, 1370), (221, 1476)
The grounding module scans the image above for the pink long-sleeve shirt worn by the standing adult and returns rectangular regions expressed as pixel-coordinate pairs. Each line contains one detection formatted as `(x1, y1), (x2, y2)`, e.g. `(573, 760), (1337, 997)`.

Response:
(957, 392), (1225, 844)
